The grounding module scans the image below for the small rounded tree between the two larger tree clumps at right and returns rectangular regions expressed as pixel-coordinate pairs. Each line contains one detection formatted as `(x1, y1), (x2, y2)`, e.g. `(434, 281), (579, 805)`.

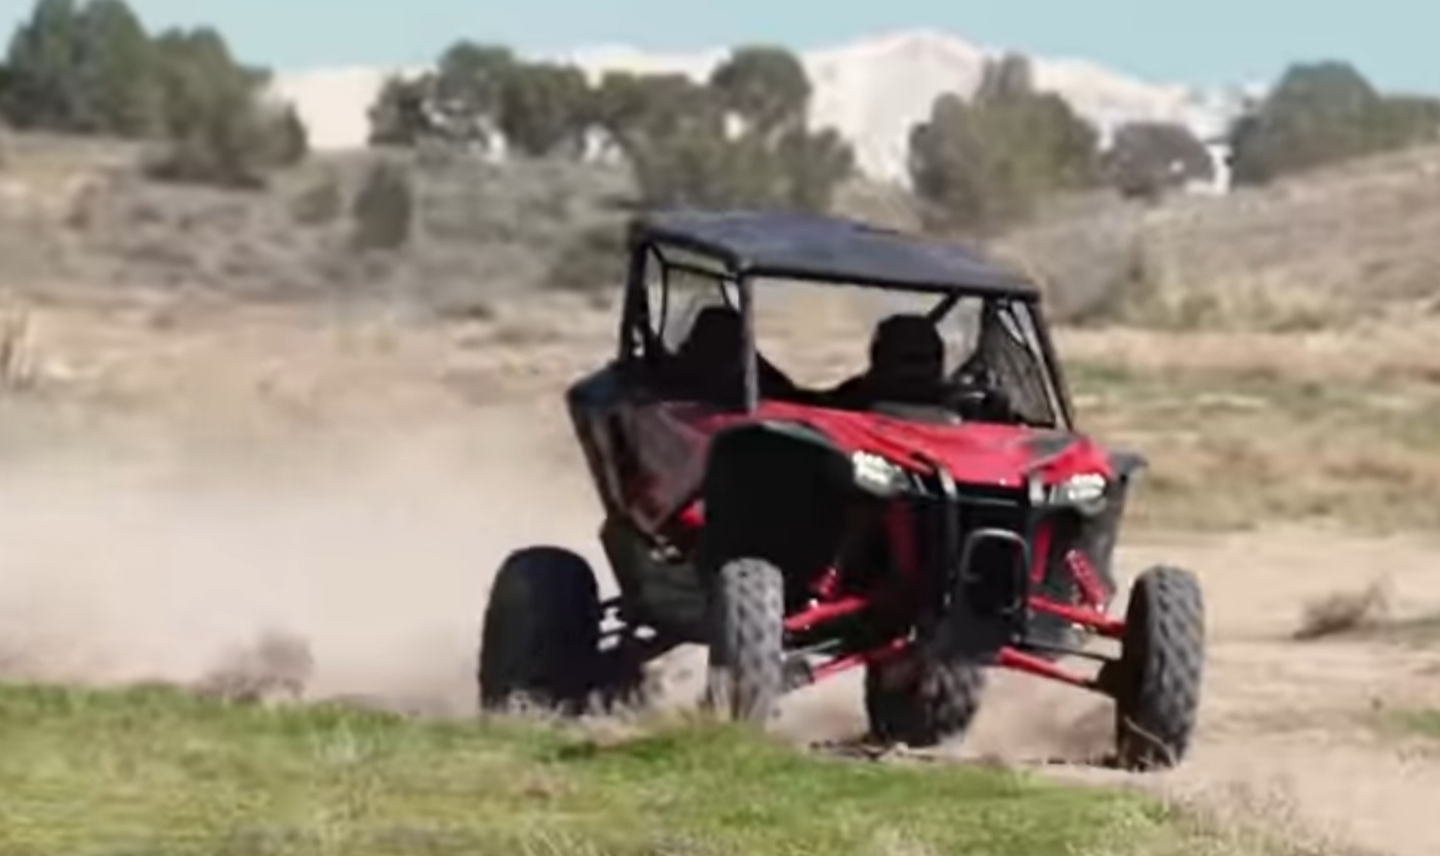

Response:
(1103, 121), (1215, 199)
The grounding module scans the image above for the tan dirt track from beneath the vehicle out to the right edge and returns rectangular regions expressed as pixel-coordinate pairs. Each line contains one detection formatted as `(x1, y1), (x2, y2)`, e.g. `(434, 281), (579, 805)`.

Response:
(771, 530), (1440, 856)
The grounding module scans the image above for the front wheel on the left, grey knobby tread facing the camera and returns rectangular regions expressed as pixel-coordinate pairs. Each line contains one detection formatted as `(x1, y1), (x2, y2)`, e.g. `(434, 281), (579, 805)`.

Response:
(706, 559), (785, 725)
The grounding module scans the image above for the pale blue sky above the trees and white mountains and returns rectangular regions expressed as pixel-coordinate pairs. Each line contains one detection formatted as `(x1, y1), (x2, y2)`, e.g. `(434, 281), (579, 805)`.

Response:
(0, 0), (1440, 92)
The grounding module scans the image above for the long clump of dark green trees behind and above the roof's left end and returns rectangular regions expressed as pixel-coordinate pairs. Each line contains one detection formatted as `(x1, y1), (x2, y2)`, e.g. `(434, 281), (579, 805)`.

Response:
(362, 42), (854, 210)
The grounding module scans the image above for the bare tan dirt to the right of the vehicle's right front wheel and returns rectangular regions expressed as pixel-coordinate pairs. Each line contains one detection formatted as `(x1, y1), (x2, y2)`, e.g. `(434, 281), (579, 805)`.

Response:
(1133, 532), (1440, 856)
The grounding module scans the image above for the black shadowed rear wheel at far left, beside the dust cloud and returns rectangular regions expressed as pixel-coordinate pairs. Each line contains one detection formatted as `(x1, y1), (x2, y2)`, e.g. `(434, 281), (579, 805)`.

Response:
(478, 546), (600, 713)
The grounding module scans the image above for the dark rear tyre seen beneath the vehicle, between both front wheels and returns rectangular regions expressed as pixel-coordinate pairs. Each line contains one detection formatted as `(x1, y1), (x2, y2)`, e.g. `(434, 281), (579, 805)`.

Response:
(865, 659), (985, 748)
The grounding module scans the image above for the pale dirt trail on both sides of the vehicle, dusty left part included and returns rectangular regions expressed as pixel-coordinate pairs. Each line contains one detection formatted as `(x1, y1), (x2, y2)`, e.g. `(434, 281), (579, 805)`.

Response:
(0, 383), (1440, 856)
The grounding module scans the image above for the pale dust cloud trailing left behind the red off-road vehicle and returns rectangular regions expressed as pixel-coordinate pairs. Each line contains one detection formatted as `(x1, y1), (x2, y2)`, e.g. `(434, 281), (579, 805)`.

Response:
(0, 408), (603, 712)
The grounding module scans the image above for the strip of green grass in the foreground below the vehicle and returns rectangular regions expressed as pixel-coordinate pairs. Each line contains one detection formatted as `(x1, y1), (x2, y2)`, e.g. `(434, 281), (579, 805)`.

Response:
(0, 687), (1278, 856)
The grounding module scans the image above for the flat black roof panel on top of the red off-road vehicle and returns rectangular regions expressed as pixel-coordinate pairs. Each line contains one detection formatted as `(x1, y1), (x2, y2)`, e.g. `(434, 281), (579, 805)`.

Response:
(632, 209), (1038, 298)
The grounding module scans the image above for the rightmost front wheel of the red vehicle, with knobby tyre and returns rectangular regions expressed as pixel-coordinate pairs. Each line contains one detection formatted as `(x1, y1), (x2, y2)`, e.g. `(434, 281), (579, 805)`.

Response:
(1107, 566), (1205, 770)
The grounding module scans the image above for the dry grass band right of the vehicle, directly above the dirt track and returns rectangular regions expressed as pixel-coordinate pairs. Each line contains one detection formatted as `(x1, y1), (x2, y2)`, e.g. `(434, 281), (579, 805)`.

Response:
(1067, 351), (1440, 533)
